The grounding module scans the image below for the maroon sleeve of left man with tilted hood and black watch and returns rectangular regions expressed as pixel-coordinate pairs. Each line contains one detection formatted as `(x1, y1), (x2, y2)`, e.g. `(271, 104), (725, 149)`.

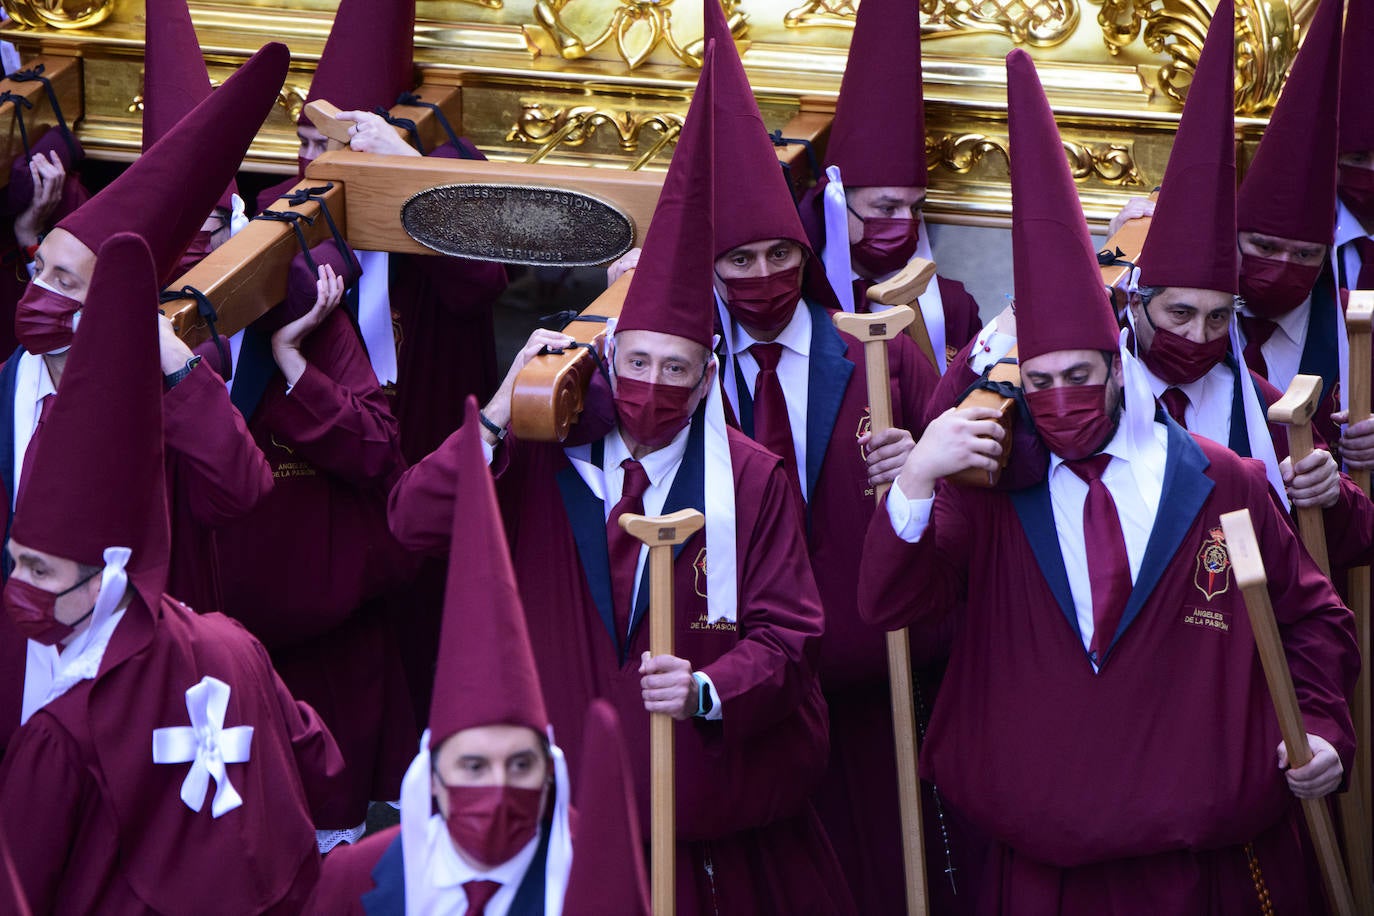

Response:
(162, 365), (272, 527)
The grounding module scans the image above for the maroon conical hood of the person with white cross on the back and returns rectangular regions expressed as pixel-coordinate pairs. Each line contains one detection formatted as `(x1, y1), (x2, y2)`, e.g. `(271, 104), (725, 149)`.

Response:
(11, 232), (170, 607)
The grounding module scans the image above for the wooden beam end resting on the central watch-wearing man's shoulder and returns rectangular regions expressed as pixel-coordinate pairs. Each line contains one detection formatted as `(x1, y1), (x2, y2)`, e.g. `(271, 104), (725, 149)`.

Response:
(511, 271), (635, 442)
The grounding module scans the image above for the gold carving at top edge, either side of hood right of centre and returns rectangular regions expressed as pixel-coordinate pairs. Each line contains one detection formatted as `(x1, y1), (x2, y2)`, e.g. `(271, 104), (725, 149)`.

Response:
(783, 0), (1080, 48)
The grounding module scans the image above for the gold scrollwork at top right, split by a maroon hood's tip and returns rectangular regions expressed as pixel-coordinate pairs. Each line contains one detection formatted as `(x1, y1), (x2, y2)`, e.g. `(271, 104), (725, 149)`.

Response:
(1098, 0), (1297, 114)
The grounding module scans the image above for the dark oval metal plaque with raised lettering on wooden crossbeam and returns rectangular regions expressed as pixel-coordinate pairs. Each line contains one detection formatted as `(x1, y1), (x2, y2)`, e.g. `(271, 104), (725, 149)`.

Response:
(401, 184), (635, 266)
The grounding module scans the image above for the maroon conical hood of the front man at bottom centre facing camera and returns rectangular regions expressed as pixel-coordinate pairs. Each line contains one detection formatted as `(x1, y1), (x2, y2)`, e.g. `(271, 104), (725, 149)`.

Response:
(430, 397), (548, 750)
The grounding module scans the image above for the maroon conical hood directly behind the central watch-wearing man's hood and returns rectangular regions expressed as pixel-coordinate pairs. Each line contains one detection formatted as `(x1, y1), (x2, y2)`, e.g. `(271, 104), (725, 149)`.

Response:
(705, 0), (807, 257)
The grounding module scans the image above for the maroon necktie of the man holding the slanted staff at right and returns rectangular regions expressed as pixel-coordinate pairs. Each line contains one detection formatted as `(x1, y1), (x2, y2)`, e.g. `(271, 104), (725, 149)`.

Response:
(1065, 455), (1131, 665)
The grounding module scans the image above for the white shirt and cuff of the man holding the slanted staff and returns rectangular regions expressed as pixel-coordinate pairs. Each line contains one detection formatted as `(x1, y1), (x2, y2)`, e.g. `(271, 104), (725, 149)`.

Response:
(888, 423), (1168, 667)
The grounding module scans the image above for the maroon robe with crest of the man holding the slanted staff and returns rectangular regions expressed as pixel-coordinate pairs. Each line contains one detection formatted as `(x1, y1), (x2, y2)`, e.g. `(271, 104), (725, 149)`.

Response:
(859, 426), (1359, 916)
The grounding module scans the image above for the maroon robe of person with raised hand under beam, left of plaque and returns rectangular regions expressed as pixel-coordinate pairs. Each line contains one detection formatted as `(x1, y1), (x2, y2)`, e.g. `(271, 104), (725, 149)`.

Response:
(218, 312), (416, 828)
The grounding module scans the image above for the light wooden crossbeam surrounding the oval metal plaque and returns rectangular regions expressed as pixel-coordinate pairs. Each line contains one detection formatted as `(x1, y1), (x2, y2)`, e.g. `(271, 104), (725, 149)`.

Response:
(305, 150), (664, 254)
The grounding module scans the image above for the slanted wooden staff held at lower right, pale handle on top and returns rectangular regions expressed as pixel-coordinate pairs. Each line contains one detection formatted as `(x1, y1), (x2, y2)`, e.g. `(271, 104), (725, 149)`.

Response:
(1221, 509), (1360, 916)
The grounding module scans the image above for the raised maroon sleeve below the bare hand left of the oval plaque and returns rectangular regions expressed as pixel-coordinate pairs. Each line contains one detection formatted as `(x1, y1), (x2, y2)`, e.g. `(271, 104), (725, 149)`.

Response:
(262, 312), (403, 485)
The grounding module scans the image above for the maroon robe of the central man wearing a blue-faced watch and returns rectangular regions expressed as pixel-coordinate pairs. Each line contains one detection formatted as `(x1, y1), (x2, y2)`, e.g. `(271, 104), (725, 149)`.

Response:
(390, 419), (852, 915)
